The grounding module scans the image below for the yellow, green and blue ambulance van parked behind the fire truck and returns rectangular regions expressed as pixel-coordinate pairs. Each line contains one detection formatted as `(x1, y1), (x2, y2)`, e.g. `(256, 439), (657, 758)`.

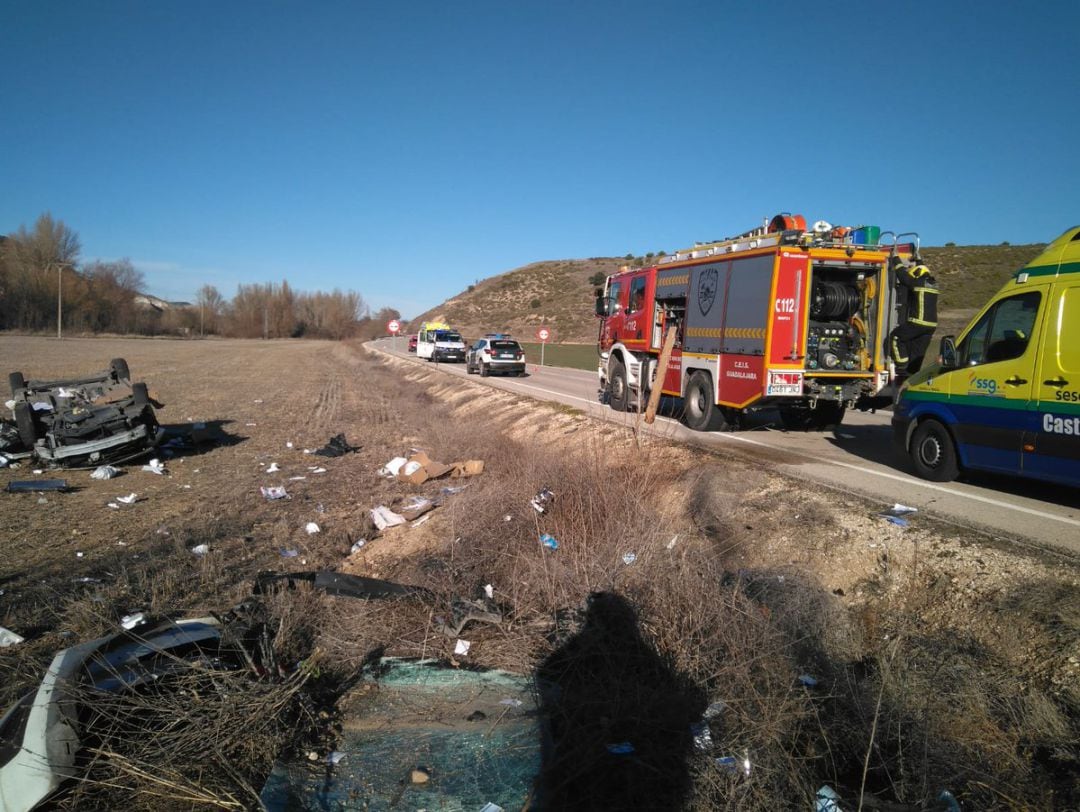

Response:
(892, 226), (1080, 487)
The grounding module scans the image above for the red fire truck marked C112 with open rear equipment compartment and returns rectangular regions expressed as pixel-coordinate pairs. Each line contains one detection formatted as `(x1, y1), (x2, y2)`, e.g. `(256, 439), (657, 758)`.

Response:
(596, 214), (918, 431)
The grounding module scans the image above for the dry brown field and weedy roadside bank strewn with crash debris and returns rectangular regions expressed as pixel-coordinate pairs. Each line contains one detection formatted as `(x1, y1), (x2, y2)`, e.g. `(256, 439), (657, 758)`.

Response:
(0, 336), (1080, 810)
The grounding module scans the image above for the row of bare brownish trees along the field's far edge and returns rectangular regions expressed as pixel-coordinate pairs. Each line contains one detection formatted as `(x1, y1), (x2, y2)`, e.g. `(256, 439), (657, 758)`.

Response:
(0, 213), (401, 339)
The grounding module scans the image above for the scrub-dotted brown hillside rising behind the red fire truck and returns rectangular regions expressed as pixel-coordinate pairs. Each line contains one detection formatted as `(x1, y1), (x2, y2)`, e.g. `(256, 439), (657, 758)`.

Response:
(409, 243), (1043, 343)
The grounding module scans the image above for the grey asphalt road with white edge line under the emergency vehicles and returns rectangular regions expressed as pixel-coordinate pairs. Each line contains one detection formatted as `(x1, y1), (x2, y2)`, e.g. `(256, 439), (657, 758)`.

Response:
(369, 338), (1080, 553)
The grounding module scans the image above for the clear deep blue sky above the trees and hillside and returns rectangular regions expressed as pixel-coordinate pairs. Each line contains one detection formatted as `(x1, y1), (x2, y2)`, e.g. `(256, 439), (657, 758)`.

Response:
(0, 0), (1080, 316)
